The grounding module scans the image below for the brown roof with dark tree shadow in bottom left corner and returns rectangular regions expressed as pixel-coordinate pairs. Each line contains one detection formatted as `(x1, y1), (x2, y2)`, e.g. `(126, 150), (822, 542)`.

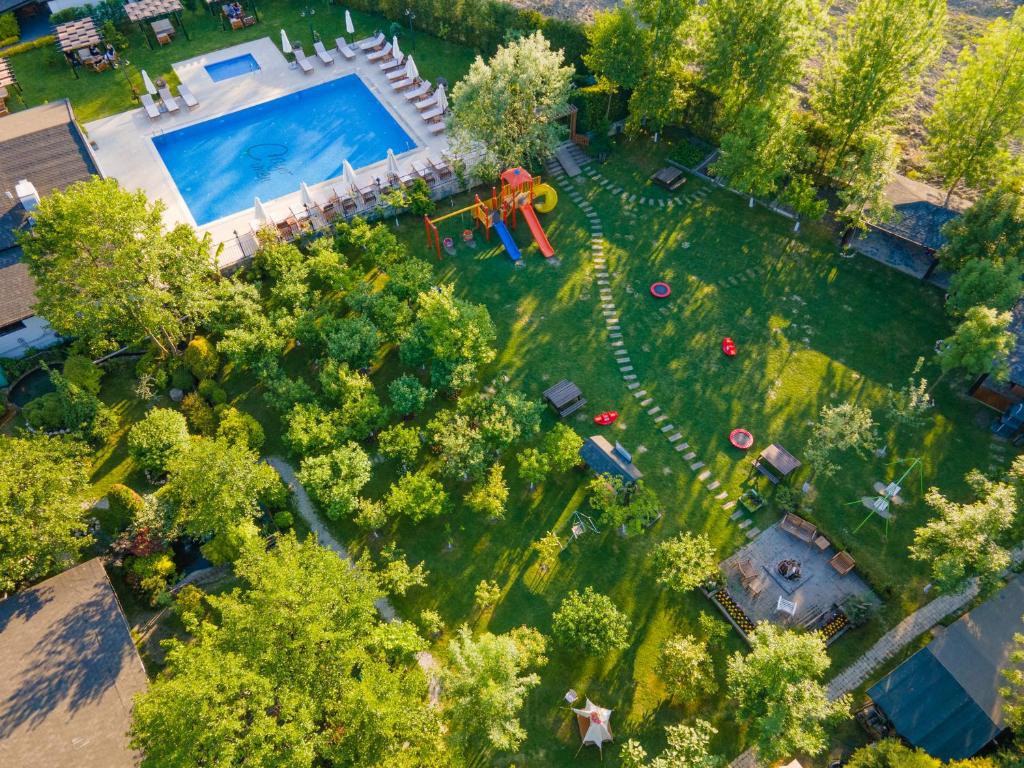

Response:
(0, 558), (147, 768)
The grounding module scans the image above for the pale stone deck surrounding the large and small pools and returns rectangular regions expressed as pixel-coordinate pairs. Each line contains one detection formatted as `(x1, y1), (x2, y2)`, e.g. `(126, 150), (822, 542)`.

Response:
(85, 38), (449, 268)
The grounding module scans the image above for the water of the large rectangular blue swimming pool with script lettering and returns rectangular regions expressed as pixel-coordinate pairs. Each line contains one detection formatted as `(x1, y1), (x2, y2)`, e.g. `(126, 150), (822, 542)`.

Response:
(153, 75), (416, 225)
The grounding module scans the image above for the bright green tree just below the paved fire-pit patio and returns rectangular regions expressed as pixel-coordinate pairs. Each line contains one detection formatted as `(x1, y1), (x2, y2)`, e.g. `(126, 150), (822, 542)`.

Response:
(726, 622), (850, 762)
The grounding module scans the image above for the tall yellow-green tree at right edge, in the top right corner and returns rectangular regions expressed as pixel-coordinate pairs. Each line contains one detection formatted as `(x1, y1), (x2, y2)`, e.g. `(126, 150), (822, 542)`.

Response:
(925, 8), (1024, 204)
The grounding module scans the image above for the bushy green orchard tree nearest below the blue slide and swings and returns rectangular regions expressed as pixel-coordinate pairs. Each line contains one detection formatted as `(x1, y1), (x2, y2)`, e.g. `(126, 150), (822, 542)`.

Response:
(400, 286), (497, 391)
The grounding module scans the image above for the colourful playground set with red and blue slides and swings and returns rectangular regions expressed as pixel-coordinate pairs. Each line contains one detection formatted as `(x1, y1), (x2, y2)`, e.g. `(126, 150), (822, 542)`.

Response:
(423, 168), (558, 264)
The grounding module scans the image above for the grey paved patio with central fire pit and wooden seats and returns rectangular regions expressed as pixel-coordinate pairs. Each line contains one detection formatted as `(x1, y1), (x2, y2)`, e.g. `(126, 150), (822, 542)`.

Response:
(713, 515), (879, 642)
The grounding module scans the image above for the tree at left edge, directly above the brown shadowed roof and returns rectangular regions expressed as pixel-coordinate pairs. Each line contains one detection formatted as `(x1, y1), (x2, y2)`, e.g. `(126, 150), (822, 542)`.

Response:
(0, 435), (91, 595)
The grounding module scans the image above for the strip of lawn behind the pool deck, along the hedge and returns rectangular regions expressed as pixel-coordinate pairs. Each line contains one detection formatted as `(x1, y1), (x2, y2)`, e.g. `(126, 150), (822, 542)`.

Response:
(8, 0), (474, 123)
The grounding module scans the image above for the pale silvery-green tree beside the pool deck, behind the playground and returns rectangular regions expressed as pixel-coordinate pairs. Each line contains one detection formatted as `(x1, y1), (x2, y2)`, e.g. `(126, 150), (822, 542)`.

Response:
(449, 32), (573, 178)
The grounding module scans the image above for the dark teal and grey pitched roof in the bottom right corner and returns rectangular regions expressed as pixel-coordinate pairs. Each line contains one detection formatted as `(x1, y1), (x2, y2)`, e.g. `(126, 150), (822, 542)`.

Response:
(867, 577), (1024, 761)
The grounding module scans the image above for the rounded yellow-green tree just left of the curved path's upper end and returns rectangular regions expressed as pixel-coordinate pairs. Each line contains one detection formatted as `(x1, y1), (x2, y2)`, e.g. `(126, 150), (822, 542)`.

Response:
(161, 437), (280, 539)
